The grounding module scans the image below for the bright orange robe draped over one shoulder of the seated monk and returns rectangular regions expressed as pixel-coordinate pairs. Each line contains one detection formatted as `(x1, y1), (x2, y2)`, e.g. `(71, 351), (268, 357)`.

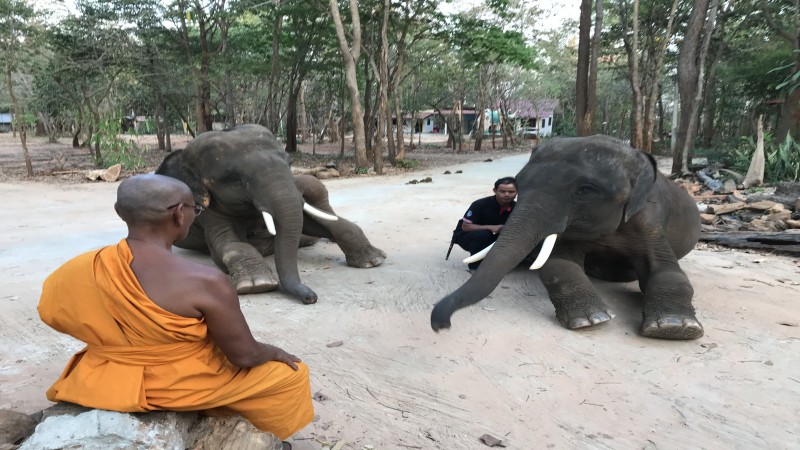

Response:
(39, 239), (314, 439)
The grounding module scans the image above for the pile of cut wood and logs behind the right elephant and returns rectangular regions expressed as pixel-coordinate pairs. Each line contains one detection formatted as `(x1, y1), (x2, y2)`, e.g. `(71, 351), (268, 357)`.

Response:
(678, 172), (800, 255)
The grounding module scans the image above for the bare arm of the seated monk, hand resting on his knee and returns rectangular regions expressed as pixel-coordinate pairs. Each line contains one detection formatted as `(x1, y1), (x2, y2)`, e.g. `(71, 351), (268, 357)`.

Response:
(196, 273), (300, 370)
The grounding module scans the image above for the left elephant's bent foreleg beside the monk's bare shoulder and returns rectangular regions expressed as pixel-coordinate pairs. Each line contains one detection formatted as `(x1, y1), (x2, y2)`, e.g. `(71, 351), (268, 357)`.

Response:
(206, 219), (279, 294)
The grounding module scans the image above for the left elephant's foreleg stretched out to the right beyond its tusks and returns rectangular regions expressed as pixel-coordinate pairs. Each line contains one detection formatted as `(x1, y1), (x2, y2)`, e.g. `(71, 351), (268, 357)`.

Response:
(303, 217), (386, 269)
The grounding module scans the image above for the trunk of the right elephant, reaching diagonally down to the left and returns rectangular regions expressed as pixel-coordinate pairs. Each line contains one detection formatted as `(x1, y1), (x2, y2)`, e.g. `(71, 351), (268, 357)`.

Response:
(431, 202), (567, 331)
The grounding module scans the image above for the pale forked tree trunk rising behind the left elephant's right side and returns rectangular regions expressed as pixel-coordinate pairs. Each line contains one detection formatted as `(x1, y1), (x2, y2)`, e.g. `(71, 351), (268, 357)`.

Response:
(329, 0), (369, 170)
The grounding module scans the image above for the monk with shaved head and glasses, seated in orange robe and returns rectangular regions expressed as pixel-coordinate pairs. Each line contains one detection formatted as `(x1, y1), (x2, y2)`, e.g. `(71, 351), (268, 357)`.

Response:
(39, 174), (314, 442)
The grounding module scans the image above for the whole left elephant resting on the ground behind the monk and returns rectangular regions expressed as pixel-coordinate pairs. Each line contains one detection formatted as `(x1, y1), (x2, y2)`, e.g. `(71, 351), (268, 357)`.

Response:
(156, 124), (386, 304)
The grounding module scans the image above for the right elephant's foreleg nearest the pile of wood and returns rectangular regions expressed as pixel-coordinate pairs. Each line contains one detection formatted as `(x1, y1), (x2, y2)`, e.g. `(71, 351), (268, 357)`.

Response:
(639, 261), (704, 340)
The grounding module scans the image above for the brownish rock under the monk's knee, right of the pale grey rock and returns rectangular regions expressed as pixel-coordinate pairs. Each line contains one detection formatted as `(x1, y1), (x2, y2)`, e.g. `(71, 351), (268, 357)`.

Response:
(188, 416), (282, 450)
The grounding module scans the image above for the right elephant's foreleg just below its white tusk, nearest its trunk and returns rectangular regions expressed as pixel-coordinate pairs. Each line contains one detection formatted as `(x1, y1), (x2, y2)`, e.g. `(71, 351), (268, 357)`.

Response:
(540, 244), (614, 330)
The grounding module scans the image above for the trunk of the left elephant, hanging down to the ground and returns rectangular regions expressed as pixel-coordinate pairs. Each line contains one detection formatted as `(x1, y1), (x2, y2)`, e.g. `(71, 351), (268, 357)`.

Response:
(251, 175), (317, 304)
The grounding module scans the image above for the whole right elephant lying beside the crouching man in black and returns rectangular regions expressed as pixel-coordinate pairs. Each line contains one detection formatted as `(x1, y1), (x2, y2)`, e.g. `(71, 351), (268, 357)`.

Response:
(431, 135), (703, 340)
